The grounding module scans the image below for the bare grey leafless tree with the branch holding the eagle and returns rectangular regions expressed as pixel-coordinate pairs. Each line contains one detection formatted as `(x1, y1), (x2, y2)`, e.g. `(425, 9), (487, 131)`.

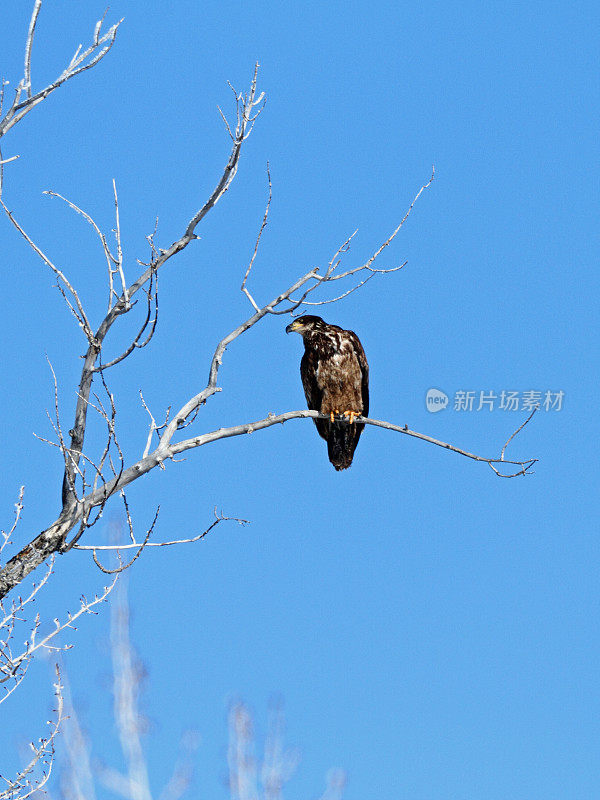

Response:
(0, 0), (535, 598)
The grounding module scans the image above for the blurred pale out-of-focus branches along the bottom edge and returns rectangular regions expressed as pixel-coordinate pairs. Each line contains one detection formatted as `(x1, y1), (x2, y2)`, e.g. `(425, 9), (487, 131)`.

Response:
(41, 576), (345, 800)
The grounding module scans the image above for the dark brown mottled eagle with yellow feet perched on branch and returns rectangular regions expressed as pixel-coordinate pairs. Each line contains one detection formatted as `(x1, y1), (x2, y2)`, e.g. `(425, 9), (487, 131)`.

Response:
(285, 314), (369, 470)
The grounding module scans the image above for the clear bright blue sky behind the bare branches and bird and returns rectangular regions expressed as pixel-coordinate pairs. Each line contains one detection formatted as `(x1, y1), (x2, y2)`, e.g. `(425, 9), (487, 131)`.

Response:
(0, 0), (600, 800)
